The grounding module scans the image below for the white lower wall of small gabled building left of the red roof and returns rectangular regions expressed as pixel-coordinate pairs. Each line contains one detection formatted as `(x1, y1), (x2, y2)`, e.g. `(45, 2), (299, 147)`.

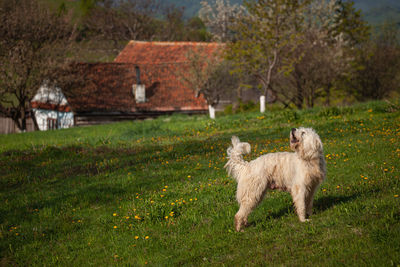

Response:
(33, 109), (74, 131)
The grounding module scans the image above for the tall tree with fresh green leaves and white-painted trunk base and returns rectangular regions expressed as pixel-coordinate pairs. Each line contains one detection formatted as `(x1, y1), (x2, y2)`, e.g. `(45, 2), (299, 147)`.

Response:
(228, 0), (305, 112)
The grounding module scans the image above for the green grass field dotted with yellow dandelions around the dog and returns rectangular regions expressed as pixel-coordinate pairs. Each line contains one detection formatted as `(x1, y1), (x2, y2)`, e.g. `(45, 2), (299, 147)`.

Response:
(0, 102), (400, 266)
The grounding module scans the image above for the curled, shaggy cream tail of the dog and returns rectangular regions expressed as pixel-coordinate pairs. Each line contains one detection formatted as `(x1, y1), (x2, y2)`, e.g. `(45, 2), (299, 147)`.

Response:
(224, 136), (251, 181)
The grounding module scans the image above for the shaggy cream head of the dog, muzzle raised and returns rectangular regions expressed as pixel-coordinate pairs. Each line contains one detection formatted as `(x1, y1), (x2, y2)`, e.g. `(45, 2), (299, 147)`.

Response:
(290, 127), (323, 160)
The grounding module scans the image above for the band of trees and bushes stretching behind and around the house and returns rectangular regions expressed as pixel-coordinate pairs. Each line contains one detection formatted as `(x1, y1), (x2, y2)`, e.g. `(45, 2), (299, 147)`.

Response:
(0, 0), (400, 131)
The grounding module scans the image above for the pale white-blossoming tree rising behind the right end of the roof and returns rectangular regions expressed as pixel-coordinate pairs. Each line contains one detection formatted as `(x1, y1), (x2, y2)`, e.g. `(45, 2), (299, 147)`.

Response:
(199, 0), (246, 42)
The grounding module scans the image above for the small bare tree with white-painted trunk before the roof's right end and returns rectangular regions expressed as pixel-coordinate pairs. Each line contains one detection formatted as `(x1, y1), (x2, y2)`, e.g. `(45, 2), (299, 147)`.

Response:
(179, 47), (239, 119)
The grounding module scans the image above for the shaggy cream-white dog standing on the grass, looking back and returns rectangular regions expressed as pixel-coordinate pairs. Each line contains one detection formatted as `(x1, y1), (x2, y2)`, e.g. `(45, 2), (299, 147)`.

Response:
(225, 128), (326, 231)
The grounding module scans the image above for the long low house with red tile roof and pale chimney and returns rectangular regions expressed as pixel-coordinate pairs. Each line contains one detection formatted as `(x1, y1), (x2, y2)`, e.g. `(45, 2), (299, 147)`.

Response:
(32, 41), (222, 128)
